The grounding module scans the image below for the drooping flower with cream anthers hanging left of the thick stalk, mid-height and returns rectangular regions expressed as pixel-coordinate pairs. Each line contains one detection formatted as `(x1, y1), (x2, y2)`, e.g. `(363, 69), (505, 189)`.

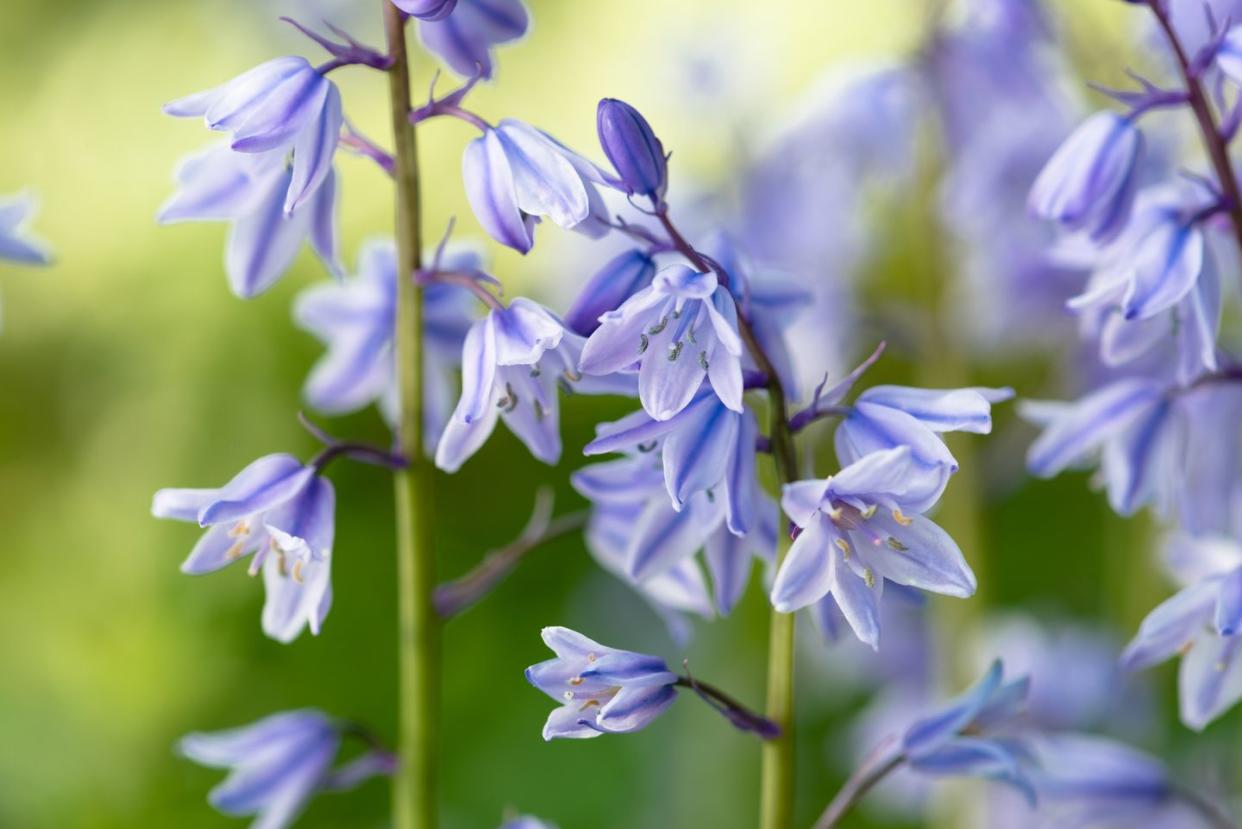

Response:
(152, 455), (337, 643)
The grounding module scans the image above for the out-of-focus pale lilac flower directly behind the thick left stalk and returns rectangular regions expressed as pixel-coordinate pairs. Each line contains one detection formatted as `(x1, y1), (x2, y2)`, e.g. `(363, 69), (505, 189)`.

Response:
(293, 240), (482, 446)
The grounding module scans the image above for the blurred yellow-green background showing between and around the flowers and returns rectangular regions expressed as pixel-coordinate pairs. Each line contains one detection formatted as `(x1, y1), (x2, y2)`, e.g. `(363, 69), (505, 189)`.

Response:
(0, 0), (1238, 829)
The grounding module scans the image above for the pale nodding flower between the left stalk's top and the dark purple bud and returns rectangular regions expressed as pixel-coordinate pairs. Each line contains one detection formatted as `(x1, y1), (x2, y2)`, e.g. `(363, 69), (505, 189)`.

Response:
(464, 117), (607, 254)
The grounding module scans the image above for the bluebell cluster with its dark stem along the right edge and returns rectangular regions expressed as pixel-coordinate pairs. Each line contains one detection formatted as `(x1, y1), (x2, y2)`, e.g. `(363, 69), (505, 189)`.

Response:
(1023, 0), (1242, 730)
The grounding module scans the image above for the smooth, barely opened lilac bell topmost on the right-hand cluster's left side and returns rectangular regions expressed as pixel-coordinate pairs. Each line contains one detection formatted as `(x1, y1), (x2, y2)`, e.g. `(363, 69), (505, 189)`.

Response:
(1030, 112), (1143, 240)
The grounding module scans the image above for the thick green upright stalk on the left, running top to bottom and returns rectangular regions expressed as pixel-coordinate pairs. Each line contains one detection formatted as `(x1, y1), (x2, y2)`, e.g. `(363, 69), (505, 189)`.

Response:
(383, 0), (440, 829)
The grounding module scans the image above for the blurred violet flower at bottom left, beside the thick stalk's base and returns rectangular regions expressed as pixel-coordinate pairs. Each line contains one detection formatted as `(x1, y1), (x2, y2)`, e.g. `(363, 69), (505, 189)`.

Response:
(178, 708), (395, 829)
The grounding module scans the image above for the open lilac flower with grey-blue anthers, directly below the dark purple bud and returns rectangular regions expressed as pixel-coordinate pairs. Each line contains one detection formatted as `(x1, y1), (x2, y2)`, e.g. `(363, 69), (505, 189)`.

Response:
(581, 265), (743, 420)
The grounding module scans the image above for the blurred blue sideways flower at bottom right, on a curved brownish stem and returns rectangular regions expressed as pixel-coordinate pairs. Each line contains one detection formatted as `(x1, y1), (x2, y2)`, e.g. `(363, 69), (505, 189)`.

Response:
(902, 661), (1036, 805)
